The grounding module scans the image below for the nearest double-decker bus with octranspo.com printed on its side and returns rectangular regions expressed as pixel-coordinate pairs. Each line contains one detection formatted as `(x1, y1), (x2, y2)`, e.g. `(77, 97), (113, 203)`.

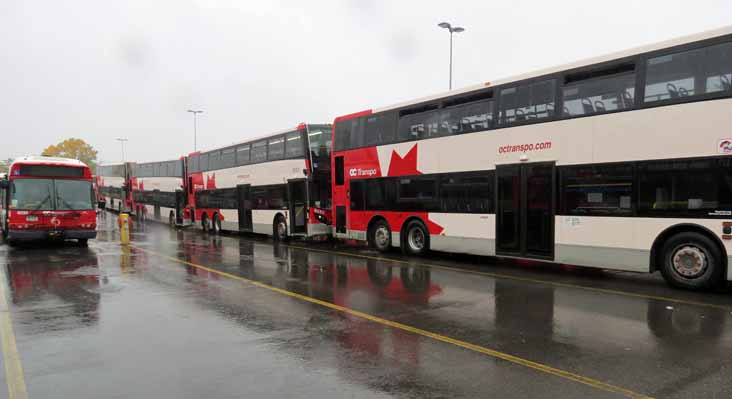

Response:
(332, 27), (732, 289)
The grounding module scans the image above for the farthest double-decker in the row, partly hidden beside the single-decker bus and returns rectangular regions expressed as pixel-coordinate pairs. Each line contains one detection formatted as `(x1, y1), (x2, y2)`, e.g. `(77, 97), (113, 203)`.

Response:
(97, 162), (133, 213)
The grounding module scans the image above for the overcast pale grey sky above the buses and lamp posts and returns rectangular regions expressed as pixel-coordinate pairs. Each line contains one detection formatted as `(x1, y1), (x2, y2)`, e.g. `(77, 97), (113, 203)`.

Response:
(0, 0), (732, 162)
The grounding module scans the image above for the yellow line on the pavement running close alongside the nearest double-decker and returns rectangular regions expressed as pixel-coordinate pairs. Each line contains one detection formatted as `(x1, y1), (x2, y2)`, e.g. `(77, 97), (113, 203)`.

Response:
(282, 241), (732, 311)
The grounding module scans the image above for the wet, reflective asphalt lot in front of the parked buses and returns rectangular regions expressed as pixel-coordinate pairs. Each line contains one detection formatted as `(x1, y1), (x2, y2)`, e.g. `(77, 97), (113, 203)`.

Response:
(0, 214), (732, 399)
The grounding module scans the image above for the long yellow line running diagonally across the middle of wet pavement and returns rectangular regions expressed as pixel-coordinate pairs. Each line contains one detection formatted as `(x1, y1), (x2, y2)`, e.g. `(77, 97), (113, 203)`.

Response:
(131, 245), (651, 399)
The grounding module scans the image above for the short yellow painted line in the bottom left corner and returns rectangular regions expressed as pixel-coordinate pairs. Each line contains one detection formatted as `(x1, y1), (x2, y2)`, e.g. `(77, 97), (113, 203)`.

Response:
(0, 265), (28, 399)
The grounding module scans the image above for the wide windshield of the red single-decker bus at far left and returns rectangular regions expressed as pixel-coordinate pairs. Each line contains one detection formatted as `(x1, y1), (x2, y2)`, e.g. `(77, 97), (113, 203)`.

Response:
(10, 179), (92, 211)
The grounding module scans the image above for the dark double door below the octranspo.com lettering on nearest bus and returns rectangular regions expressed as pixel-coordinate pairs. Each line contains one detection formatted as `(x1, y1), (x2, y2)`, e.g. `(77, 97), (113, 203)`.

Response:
(496, 162), (555, 259)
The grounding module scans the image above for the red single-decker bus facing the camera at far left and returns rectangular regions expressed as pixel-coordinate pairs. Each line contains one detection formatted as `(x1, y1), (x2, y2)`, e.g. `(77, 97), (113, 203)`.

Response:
(0, 157), (97, 245)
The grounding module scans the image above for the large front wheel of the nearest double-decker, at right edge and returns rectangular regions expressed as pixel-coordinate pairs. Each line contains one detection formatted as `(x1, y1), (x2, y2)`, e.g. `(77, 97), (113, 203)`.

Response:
(661, 232), (723, 290)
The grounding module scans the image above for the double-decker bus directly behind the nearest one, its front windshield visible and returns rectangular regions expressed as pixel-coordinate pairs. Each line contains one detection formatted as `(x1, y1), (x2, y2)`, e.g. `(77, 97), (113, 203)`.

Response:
(185, 123), (332, 239)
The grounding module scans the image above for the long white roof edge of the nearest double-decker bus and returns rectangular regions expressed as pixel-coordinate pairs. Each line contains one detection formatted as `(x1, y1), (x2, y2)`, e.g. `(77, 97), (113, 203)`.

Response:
(372, 25), (732, 114)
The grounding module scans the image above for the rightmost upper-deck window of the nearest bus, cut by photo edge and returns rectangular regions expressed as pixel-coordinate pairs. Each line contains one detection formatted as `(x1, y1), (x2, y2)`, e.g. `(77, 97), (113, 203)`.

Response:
(644, 43), (732, 103)
